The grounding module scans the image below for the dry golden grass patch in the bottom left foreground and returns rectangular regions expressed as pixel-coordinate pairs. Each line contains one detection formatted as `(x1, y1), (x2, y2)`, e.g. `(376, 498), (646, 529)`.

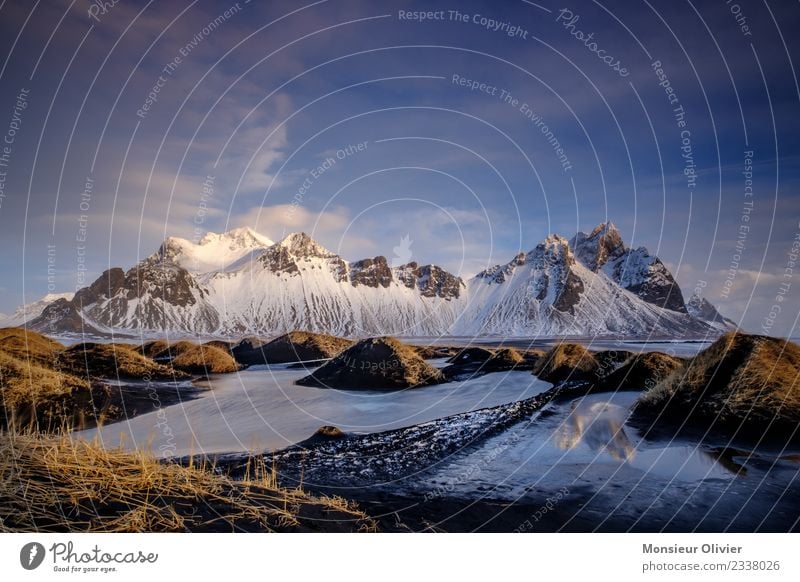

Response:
(0, 433), (375, 532)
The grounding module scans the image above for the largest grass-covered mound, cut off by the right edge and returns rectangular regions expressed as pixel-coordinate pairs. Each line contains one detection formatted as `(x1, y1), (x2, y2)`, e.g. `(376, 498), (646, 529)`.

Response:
(634, 332), (800, 440)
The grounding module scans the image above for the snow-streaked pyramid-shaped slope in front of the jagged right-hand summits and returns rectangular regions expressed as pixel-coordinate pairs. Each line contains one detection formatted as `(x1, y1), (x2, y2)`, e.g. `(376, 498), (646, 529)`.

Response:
(453, 235), (713, 337)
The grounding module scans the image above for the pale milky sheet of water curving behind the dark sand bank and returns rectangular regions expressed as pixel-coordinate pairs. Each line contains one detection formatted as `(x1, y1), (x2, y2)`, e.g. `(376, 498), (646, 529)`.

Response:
(84, 360), (550, 456)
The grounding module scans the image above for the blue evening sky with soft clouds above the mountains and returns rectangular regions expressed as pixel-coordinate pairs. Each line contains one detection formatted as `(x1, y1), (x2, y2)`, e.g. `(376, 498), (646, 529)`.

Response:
(0, 0), (800, 334)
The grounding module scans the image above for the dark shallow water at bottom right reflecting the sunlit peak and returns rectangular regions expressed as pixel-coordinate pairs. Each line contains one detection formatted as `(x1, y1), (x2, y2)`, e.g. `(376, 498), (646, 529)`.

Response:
(393, 393), (800, 531)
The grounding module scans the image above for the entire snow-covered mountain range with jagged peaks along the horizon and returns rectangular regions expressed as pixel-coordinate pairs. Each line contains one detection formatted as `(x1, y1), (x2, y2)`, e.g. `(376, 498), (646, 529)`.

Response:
(14, 223), (733, 337)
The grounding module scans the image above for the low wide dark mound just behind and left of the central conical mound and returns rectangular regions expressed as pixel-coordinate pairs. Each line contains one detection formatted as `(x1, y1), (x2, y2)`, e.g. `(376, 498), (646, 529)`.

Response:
(233, 331), (353, 365)
